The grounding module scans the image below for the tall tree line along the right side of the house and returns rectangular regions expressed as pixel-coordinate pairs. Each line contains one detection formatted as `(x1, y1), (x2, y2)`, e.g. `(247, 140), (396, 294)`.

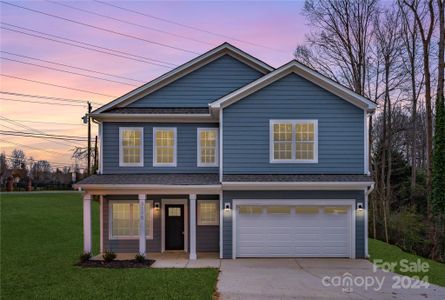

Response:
(295, 0), (445, 261)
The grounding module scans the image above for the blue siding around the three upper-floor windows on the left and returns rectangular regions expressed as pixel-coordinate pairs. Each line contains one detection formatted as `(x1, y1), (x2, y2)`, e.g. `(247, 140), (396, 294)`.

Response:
(103, 122), (219, 174)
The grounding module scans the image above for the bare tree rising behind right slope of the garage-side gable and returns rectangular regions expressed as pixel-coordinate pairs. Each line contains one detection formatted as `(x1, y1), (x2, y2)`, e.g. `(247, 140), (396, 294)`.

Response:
(295, 0), (377, 96)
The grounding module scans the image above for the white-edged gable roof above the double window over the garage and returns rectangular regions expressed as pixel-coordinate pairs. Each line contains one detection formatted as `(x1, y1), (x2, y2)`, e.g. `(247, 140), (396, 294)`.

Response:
(209, 60), (377, 112)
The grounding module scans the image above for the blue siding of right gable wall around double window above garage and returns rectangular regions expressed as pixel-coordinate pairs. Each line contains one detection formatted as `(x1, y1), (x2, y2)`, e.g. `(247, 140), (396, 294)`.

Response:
(223, 74), (365, 174)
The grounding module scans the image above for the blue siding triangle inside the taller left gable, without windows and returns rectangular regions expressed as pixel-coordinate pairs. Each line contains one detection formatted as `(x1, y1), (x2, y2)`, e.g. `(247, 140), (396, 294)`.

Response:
(128, 55), (263, 107)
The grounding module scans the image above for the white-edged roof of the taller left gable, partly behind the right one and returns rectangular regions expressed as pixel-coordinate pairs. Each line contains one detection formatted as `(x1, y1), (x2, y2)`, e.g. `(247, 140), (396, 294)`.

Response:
(91, 42), (274, 116)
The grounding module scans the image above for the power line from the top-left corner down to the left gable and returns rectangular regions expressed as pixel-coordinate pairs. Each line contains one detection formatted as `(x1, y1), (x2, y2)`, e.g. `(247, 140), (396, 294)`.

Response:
(2, 1), (199, 54)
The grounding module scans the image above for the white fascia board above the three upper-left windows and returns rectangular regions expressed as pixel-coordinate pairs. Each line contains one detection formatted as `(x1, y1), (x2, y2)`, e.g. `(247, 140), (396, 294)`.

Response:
(91, 113), (218, 123)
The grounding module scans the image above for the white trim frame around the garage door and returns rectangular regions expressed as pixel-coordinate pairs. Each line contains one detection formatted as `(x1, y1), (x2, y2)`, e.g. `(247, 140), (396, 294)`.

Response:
(232, 199), (356, 259)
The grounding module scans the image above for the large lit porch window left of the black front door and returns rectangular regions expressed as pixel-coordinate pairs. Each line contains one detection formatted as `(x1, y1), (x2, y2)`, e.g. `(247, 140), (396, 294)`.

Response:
(110, 201), (153, 239)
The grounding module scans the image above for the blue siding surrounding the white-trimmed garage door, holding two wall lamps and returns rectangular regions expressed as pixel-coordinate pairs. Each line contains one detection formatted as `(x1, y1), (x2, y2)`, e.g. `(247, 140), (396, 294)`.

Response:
(222, 191), (365, 258)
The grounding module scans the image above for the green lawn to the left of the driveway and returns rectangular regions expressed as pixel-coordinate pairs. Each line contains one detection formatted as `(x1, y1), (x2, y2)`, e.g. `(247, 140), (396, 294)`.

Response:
(0, 192), (218, 299)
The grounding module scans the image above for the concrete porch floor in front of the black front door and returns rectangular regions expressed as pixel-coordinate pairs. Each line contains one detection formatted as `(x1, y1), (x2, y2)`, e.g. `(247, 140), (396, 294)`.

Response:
(91, 251), (221, 268)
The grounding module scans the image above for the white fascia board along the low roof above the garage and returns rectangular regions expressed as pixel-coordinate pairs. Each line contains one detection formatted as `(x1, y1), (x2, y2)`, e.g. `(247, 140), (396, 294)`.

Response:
(222, 181), (373, 191)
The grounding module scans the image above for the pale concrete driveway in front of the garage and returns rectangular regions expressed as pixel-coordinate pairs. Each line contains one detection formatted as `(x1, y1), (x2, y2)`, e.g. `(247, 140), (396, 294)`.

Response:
(218, 259), (445, 300)
